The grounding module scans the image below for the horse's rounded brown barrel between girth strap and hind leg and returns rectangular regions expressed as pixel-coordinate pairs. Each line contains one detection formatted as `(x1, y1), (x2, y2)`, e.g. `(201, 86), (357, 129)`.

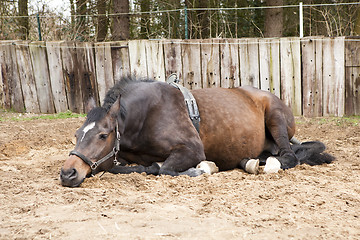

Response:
(192, 88), (266, 170)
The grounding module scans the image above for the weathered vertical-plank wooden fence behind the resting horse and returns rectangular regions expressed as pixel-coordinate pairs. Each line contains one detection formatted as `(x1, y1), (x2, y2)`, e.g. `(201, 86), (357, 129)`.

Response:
(0, 37), (360, 117)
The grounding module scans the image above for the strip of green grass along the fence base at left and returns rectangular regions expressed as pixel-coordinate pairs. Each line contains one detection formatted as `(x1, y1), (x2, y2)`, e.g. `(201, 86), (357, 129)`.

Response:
(0, 109), (86, 122)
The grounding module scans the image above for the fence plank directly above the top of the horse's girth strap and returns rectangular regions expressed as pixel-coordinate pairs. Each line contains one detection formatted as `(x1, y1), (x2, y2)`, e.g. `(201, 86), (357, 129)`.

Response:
(162, 40), (184, 86)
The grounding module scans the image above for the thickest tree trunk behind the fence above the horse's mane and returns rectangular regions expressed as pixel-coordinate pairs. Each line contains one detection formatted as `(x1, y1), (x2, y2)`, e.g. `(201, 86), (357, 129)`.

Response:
(112, 0), (130, 41)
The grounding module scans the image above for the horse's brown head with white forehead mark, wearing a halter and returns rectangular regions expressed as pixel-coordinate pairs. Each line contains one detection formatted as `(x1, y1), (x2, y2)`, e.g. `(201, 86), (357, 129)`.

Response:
(60, 98), (121, 187)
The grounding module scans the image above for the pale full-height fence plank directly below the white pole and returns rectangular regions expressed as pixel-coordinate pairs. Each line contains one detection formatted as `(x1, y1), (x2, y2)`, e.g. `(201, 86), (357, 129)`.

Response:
(301, 37), (322, 117)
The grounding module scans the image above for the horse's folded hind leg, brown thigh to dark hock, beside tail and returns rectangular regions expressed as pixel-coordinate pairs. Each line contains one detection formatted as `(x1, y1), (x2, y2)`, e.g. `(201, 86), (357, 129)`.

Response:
(265, 109), (300, 169)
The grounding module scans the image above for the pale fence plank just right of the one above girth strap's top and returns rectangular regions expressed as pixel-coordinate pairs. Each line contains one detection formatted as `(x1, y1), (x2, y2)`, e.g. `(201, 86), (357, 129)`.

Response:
(181, 40), (202, 89)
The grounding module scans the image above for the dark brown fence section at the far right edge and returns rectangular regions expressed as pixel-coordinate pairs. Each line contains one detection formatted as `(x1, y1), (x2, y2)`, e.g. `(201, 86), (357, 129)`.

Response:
(345, 37), (360, 116)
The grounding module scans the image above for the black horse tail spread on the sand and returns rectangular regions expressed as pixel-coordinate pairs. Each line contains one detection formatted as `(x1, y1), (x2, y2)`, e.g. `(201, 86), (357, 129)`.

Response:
(291, 141), (335, 166)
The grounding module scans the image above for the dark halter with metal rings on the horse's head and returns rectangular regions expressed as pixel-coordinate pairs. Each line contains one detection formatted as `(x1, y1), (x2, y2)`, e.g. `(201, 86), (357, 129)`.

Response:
(69, 121), (120, 176)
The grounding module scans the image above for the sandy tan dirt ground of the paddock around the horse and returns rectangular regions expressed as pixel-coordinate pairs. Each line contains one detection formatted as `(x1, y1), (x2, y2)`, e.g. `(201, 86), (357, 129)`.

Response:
(0, 113), (360, 239)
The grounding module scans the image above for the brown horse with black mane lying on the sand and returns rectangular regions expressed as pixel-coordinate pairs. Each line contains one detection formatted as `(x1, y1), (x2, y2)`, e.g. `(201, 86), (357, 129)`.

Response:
(60, 76), (334, 187)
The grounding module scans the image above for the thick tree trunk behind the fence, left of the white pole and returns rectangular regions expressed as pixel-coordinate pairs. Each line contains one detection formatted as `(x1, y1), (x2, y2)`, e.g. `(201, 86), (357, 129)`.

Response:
(264, 0), (283, 37)
